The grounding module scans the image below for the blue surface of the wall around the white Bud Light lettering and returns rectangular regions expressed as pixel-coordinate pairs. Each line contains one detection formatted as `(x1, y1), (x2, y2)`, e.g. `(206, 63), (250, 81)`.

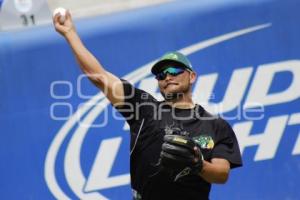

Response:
(0, 0), (300, 200)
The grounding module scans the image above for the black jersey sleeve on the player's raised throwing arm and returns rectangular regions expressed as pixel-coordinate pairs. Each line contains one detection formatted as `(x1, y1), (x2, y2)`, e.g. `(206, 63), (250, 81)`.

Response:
(116, 79), (156, 127)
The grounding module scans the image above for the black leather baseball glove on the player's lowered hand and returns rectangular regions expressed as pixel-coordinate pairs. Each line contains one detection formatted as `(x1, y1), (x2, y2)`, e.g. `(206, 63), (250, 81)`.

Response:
(159, 135), (203, 181)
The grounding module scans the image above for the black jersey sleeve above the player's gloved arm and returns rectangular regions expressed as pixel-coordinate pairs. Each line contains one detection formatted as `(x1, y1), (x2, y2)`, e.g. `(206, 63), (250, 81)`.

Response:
(212, 119), (243, 168)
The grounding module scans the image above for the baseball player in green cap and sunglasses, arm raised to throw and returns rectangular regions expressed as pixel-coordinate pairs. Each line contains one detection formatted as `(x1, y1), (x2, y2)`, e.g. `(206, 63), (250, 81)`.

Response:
(53, 12), (242, 200)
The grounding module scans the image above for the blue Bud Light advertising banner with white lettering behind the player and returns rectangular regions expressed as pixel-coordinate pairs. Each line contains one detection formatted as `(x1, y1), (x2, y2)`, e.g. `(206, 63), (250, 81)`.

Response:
(0, 0), (300, 200)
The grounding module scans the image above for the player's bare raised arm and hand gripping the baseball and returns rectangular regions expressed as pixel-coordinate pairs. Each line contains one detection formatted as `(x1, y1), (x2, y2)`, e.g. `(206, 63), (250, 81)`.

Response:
(53, 11), (124, 105)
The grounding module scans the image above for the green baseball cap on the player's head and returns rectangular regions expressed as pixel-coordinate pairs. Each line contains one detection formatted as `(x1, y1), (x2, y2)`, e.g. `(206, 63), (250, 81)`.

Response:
(151, 52), (194, 75)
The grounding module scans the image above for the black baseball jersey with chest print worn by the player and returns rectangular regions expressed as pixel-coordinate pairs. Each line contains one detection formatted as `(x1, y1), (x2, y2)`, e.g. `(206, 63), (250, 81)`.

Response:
(117, 80), (242, 200)
